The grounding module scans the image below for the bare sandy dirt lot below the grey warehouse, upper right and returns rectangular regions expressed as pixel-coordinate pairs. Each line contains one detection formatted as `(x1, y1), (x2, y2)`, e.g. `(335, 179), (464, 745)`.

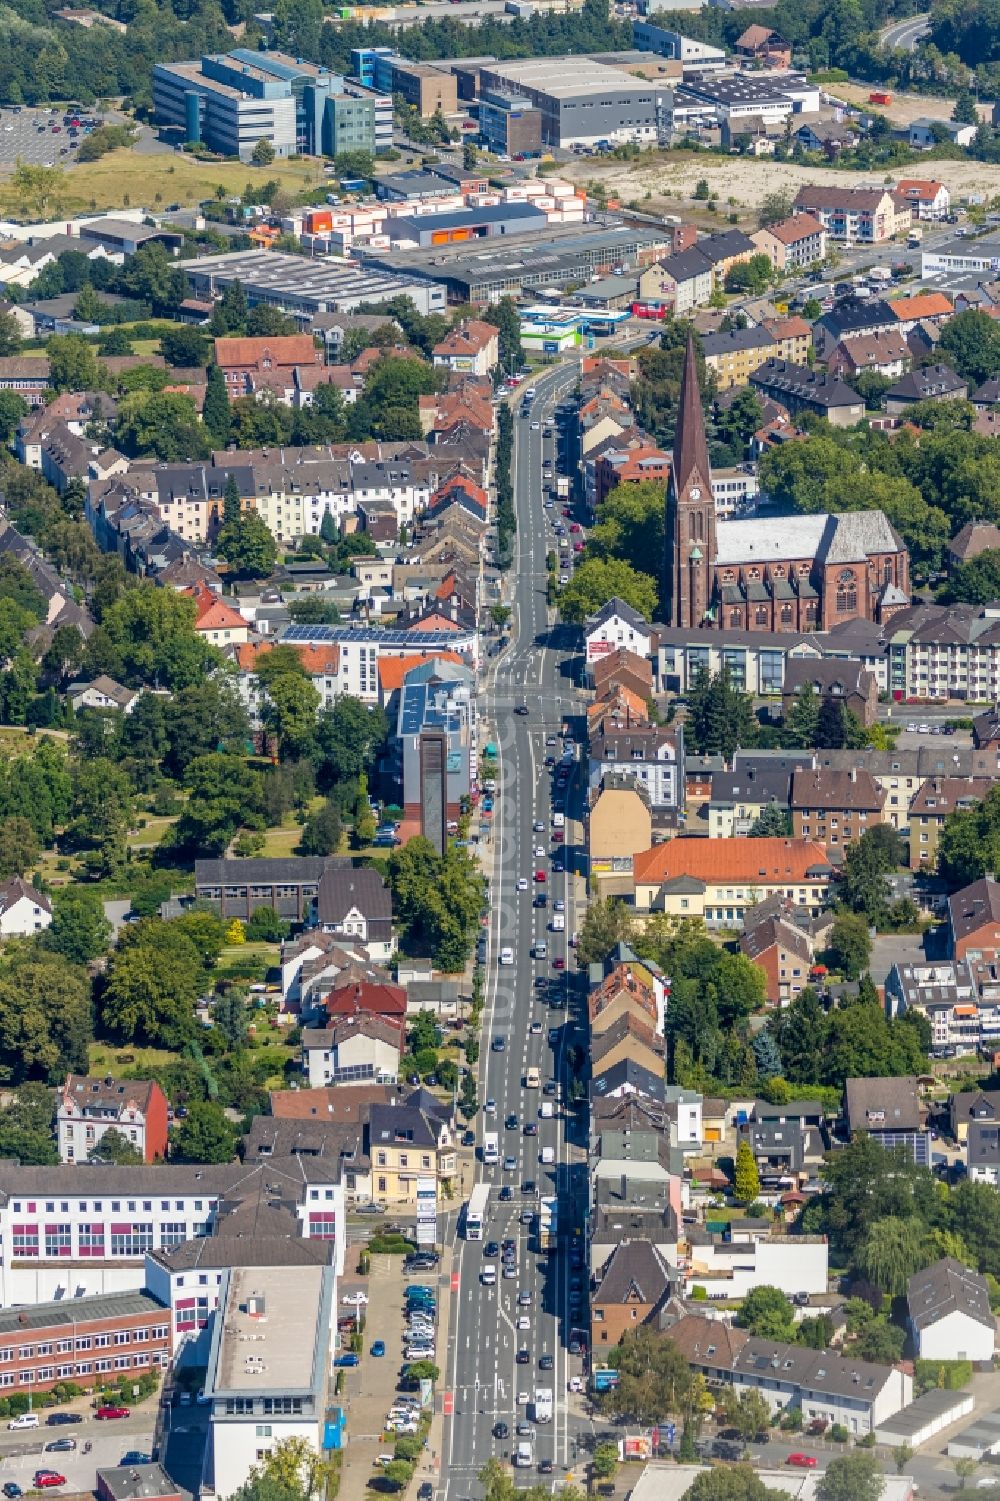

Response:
(560, 152), (1000, 227)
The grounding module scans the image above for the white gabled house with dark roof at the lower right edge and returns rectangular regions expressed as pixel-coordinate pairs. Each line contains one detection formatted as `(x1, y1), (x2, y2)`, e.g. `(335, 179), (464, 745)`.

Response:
(907, 1256), (997, 1363)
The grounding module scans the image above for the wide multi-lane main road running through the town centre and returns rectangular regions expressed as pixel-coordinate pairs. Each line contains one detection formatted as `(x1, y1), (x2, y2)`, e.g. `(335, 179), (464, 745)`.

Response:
(440, 363), (586, 1501)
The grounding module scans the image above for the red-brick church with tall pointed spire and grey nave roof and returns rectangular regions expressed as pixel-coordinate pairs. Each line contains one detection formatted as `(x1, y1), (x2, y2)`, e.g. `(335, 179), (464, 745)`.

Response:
(662, 339), (910, 632)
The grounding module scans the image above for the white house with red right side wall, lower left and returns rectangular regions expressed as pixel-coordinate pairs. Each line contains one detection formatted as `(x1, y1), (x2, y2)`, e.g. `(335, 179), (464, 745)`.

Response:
(56, 1073), (167, 1162)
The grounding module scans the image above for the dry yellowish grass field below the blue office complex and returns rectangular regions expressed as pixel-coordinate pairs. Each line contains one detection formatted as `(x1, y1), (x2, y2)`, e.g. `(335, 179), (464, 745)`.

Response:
(0, 150), (323, 219)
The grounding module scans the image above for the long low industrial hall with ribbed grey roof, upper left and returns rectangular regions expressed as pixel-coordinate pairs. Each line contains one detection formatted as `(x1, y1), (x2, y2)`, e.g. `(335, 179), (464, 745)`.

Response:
(185, 251), (446, 324)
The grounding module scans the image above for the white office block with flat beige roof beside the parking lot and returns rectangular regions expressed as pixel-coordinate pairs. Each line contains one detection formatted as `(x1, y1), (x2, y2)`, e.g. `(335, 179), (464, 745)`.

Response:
(204, 1267), (336, 1501)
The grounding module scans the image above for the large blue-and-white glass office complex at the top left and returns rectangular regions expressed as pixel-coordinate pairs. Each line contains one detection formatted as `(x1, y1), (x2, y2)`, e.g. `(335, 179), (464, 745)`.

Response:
(153, 47), (342, 161)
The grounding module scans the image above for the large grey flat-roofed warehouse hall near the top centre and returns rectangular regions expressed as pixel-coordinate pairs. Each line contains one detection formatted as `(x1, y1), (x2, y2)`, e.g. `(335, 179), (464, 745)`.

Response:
(480, 57), (662, 147)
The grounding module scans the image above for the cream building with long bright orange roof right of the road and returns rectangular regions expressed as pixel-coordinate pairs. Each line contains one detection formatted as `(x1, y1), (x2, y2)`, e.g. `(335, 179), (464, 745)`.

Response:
(632, 839), (832, 928)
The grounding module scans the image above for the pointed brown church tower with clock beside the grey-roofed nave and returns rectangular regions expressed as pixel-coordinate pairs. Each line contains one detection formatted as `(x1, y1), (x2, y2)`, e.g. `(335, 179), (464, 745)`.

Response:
(662, 333), (716, 626)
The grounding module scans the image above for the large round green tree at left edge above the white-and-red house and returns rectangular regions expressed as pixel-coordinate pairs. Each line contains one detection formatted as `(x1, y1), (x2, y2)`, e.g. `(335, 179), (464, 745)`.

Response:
(0, 950), (93, 1084)
